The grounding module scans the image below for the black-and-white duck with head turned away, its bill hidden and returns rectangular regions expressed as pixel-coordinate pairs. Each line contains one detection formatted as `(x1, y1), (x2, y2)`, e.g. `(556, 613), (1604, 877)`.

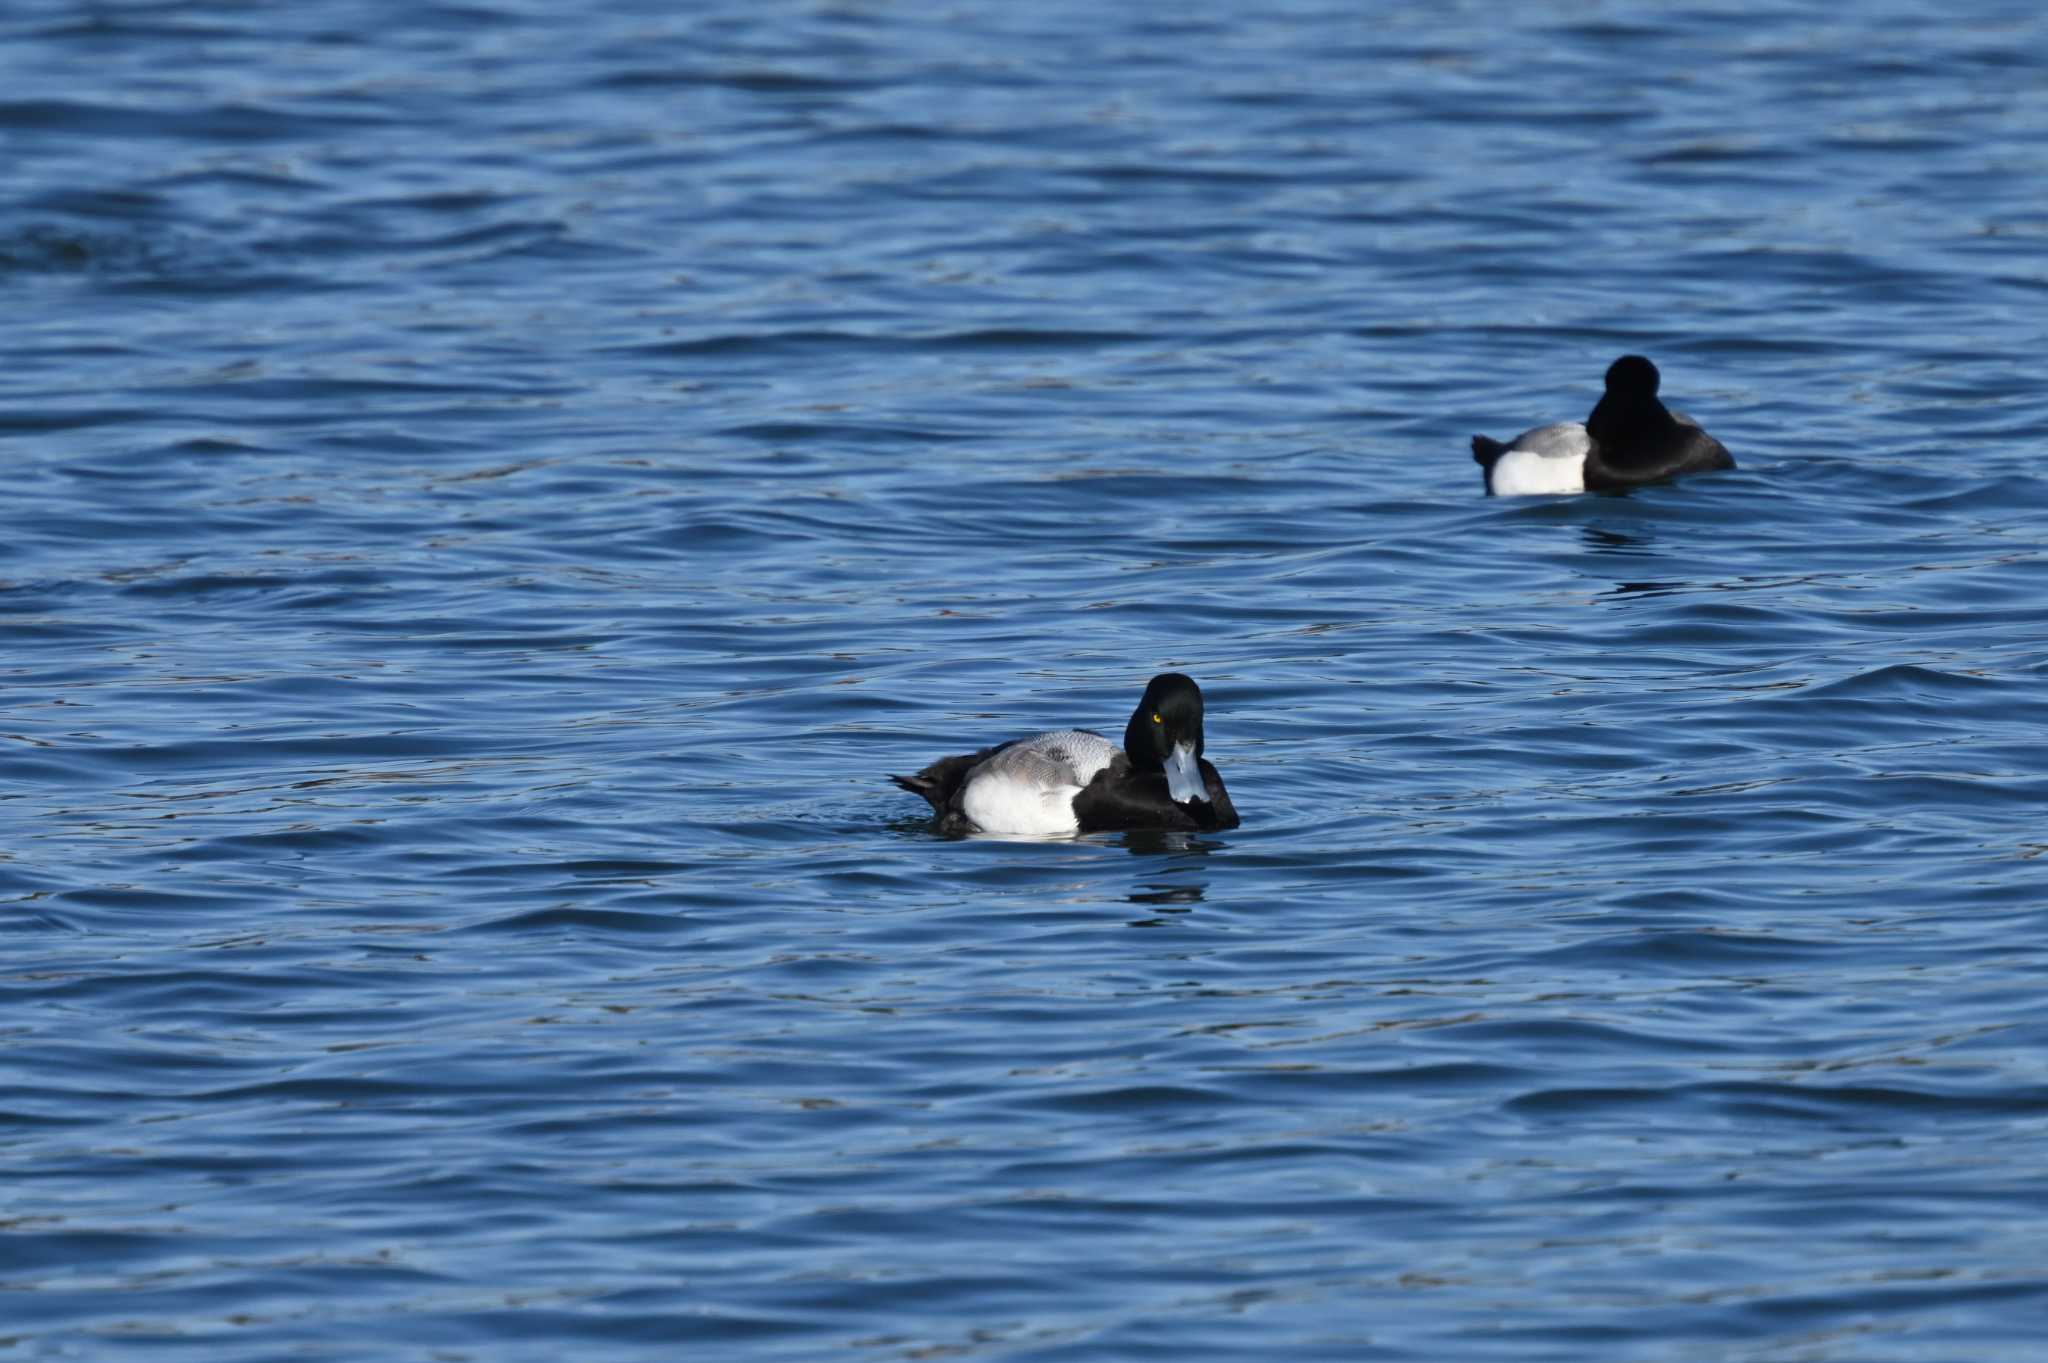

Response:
(1473, 354), (1735, 497)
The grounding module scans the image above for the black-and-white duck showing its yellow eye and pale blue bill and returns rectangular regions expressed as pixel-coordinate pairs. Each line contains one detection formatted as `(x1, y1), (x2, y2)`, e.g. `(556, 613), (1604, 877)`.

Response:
(889, 671), (1237, 837)
